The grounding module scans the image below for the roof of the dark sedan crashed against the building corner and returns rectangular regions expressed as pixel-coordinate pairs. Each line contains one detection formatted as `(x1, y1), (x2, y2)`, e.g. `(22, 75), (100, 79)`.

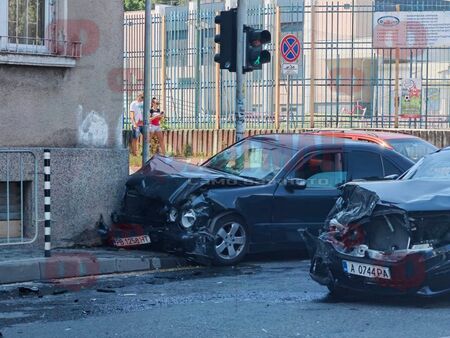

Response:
(247, 134), (379, 151)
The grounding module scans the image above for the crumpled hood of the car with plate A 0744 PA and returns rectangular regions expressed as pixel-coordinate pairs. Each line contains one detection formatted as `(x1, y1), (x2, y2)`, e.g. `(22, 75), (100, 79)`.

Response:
(350, 179), (450, 212)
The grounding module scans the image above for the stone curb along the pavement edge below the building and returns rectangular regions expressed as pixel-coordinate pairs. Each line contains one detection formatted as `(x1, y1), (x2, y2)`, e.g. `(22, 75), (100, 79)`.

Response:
(0, 252), (189, 284)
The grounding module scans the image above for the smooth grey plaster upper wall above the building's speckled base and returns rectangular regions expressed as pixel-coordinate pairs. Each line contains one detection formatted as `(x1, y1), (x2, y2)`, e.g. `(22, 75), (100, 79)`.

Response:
(0, 0), (123, 147)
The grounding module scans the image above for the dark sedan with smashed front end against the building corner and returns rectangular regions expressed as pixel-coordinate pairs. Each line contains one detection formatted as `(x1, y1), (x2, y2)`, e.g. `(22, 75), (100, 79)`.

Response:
(109, 134), (413, 265)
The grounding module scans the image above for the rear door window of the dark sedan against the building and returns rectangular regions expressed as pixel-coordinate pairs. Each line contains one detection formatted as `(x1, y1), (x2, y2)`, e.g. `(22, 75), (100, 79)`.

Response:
(348, 151), (385, 180)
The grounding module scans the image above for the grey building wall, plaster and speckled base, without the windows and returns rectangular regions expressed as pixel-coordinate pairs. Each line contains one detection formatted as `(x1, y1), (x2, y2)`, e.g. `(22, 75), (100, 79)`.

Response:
(0, 0), (128, 246)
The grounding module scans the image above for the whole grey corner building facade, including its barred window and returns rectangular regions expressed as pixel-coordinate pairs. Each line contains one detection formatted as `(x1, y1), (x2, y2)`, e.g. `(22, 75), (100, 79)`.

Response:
(0, 0), (128, 246)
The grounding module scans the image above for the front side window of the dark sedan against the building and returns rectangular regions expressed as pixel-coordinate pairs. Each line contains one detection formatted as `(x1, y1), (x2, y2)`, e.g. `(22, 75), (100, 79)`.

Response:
(289, 152), (347, 189)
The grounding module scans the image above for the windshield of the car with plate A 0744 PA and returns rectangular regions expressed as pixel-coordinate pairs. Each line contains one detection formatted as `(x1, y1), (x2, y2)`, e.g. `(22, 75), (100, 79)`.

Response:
(401, 151), (450, 180)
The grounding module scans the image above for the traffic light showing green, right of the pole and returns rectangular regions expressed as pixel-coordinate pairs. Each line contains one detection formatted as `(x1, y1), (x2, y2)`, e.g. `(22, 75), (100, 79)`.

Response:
(244, 26), (272, 73)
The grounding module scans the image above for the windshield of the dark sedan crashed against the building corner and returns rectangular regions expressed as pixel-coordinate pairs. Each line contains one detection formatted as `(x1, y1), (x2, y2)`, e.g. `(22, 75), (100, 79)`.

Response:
(203, 139), (297, 181)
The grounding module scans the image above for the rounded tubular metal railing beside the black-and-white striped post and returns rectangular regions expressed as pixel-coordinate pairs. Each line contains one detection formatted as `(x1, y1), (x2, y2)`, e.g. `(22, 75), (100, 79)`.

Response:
(0, 150), (38, 246)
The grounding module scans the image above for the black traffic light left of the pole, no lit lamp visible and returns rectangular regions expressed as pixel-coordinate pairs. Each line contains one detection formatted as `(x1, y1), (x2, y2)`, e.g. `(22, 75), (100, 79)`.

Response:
(214, 8), (237, 72)
